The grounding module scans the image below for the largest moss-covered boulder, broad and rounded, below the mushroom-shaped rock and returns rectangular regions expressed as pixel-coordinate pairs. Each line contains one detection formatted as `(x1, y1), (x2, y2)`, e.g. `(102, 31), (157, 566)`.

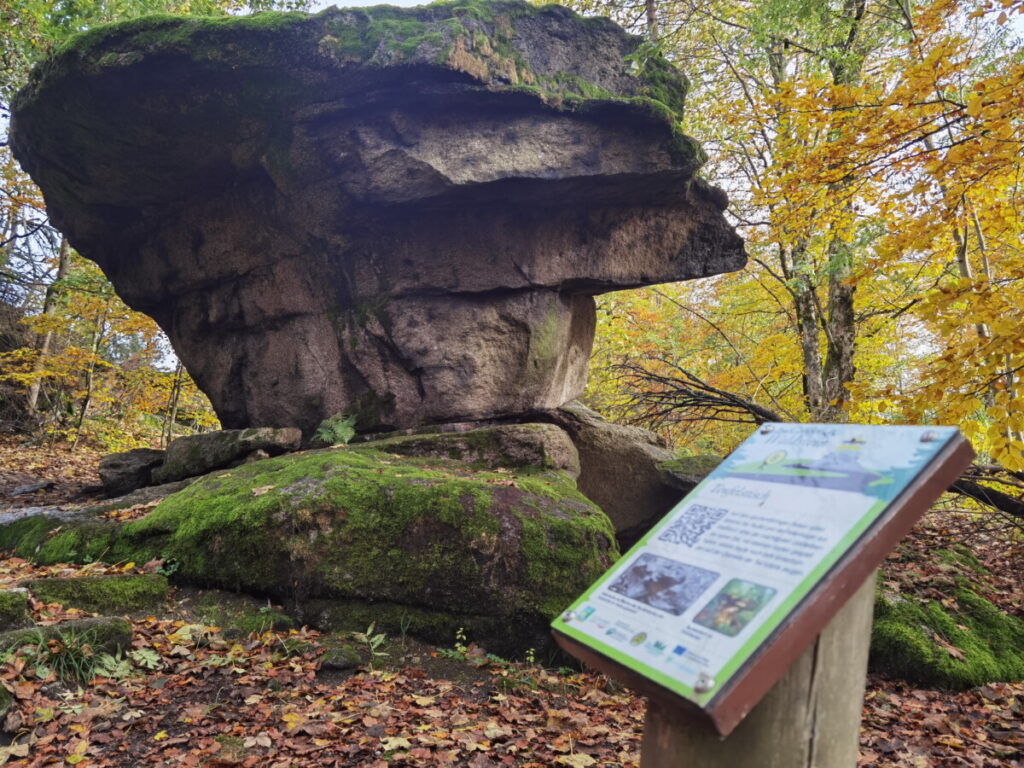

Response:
(0, 446), (618, 653)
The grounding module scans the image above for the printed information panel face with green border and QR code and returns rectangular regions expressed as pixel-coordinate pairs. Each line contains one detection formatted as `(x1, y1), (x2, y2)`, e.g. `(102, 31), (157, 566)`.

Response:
(552, 424), (957, 705)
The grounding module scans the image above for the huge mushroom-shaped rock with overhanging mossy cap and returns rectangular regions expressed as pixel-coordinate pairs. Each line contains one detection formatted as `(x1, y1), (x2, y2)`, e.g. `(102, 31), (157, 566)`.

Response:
(11, 0), (745, 432)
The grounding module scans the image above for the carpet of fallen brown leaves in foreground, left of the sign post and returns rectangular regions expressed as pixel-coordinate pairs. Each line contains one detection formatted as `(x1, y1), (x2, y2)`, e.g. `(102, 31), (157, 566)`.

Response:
(0, 569), (643, 768)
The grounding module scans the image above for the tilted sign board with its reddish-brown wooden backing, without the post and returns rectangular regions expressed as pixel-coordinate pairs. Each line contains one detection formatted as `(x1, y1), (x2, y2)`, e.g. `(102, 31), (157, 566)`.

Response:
(552, 424), (973, 733)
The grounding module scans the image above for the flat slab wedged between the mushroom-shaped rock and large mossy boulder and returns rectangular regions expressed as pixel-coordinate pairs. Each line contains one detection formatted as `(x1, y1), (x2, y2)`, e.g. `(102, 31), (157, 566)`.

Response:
(367, 424), (580, 478)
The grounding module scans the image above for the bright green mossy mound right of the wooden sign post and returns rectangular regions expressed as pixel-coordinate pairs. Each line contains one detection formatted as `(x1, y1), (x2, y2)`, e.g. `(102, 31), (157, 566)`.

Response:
(871, 549), (1024, 689)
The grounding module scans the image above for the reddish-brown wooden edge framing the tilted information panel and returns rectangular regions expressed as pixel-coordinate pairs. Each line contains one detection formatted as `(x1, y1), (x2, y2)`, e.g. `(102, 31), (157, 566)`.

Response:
(552, 425), (974, 736)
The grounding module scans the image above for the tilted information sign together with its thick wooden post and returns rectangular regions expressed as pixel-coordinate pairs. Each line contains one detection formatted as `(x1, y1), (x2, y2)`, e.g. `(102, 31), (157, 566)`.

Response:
(552, 424), (974, 768)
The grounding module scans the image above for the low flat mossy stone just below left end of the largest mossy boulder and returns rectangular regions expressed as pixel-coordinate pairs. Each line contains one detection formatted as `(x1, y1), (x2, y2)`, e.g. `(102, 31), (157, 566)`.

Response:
(22, 573), (168, 613)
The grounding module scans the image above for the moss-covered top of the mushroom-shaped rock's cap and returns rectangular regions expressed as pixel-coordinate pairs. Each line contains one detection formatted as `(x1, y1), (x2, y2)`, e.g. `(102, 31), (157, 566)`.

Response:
(18, 0), (699, 158)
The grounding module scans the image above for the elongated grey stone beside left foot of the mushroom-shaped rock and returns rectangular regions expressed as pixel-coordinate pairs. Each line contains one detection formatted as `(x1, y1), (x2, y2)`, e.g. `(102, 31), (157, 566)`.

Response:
(153, 427), (302, 483)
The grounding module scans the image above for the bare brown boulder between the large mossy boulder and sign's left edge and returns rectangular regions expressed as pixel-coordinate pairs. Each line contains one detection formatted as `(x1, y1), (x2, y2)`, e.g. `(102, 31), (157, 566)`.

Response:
(543, 401), (683, 551)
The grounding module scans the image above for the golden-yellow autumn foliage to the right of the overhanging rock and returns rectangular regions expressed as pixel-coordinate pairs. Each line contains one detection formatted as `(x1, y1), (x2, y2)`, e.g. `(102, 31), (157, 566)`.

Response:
(589, 0), (1024, 470)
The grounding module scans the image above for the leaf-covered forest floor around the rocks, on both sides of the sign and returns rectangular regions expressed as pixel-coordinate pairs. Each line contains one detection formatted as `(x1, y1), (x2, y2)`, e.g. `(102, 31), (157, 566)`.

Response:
(0, 440), (1024, 768)
